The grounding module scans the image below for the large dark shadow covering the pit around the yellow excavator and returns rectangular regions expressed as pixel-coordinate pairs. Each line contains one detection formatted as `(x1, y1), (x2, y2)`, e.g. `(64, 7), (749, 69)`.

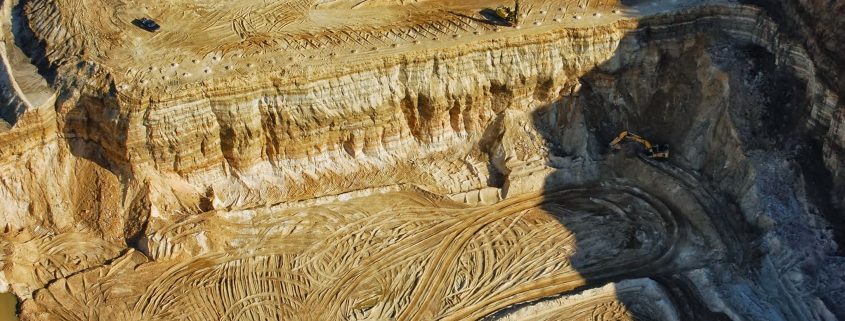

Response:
(482, 13), (845, 321)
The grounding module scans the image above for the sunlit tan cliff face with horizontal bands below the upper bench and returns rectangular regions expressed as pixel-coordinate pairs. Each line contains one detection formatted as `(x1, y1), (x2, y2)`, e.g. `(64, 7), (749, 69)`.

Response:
(113, 29), (621, 208)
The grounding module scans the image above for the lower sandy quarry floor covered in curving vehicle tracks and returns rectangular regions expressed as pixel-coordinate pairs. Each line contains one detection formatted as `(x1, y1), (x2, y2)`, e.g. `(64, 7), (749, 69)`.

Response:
(23, 179), (704, 321)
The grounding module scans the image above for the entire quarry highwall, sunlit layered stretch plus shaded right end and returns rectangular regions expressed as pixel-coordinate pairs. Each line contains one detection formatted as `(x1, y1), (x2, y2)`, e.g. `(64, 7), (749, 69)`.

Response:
(0, 5), (845, 320)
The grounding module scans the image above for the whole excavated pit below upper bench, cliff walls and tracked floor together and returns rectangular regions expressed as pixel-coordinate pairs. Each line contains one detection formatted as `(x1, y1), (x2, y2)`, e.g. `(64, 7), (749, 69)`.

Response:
(0, 5), (845, 320)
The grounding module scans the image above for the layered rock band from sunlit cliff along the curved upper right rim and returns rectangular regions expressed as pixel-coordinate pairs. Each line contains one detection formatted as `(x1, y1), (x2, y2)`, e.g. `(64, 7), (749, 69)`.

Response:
(9, 7), (839, 220)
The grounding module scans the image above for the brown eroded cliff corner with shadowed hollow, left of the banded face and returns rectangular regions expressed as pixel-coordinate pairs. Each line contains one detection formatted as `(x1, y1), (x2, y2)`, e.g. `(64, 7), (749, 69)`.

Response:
(59, 96), (150, 244)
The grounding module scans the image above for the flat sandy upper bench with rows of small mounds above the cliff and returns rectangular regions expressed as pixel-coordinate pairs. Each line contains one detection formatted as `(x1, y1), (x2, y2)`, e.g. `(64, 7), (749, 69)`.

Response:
(29, 0), (700, 91)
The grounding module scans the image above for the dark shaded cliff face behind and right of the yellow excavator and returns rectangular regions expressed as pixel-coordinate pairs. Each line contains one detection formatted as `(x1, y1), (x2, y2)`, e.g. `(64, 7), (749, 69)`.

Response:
(552, 24), (843, 320)
